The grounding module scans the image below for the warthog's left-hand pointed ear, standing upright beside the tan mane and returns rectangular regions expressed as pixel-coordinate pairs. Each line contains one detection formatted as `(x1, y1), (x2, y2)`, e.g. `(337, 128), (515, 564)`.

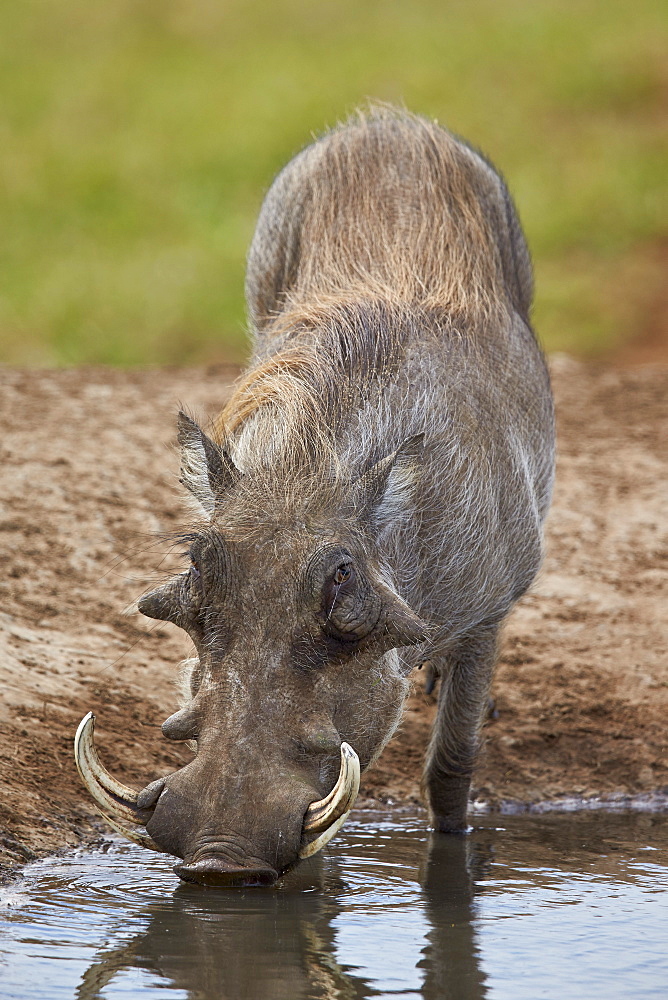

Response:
(177, 411), (241, 518)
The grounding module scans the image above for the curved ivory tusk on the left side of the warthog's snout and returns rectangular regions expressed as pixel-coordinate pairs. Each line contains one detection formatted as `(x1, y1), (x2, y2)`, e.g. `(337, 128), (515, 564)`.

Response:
(74, 712), (162, 853)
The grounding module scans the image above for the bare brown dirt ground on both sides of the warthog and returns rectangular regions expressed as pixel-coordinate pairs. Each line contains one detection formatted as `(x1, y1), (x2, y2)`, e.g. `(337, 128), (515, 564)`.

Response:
(0, 357), (668, 874)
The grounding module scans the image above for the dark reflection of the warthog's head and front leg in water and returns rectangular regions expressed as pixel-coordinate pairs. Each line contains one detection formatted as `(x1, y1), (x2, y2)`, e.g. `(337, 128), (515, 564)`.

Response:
(76, 831), (500, 1000)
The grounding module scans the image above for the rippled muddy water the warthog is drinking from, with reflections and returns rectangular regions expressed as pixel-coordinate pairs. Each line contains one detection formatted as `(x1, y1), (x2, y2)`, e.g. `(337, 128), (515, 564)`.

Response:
(0, 813), (668, 1000)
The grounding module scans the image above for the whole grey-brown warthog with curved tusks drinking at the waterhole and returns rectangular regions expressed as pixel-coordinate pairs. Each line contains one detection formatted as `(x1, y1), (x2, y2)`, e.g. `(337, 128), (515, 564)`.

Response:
(77, 109), (554, 885)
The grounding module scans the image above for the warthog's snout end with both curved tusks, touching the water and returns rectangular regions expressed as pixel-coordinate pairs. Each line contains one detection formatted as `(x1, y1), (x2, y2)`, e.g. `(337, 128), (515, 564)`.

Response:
(75, 713), (360, 886)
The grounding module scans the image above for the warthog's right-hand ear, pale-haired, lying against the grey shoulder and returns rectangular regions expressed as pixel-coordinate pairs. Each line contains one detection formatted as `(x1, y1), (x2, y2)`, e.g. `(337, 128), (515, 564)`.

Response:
(354, 434), (424, 529)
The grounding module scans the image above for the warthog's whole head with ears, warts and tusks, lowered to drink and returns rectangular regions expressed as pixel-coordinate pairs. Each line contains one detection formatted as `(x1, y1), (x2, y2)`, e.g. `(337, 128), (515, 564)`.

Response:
(77, 414), (427, 885)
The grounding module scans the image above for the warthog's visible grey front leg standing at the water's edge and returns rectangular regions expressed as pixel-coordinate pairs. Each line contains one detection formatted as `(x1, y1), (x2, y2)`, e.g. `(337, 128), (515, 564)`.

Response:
(422, 625), (499, 833)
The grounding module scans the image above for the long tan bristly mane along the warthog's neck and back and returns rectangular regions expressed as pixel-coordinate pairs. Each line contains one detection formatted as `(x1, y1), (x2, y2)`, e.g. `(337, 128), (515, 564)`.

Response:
(215, 108), (509, 474)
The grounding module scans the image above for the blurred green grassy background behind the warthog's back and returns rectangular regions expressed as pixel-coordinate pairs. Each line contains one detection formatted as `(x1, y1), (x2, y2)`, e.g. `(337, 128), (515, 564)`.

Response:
(0, 0), (668, 365)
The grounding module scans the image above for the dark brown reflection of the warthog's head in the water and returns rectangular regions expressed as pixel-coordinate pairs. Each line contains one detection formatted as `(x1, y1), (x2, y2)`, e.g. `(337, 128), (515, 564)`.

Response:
(77, 872), (374, 1000)
